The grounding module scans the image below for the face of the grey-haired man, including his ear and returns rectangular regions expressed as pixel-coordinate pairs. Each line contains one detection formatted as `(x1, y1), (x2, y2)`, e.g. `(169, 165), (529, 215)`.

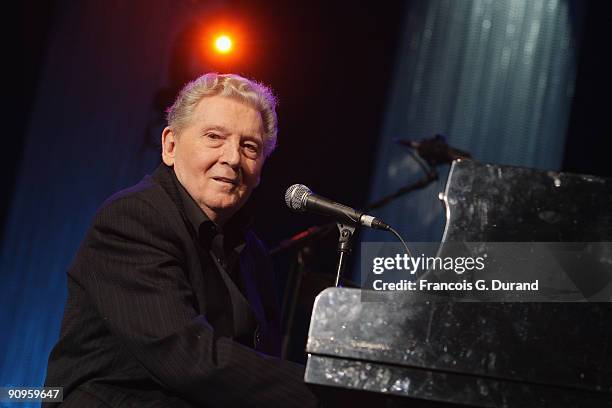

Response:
(162, 96), (265, 225)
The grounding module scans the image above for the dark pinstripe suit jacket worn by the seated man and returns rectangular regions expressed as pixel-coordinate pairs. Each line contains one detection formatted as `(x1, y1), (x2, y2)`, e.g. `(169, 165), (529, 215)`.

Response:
(43, 164), (316, 407)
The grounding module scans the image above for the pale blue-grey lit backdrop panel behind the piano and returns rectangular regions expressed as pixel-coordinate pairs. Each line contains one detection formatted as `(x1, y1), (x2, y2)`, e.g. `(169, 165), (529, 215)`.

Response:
(354, 0), (584, 253)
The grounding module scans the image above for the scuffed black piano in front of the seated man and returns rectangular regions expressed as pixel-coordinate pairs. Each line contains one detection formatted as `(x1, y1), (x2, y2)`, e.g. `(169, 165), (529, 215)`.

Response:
(305, 160), (612, 408)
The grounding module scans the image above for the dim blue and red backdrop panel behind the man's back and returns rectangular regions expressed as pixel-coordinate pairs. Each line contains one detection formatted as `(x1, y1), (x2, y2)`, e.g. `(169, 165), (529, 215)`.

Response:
(0, 0), (219, 405)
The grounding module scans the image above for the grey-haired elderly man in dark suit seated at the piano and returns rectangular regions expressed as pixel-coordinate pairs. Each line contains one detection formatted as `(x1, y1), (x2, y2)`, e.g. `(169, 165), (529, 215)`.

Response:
(45, 74), (316, 407)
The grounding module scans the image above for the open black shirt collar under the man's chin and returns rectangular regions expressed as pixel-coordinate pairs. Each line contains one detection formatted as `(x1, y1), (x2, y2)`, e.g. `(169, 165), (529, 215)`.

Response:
(171, 169), (251, 249)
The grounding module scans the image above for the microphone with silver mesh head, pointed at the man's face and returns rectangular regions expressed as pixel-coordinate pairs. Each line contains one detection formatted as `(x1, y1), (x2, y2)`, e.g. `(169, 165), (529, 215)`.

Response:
(285, 184), (391, 231)
